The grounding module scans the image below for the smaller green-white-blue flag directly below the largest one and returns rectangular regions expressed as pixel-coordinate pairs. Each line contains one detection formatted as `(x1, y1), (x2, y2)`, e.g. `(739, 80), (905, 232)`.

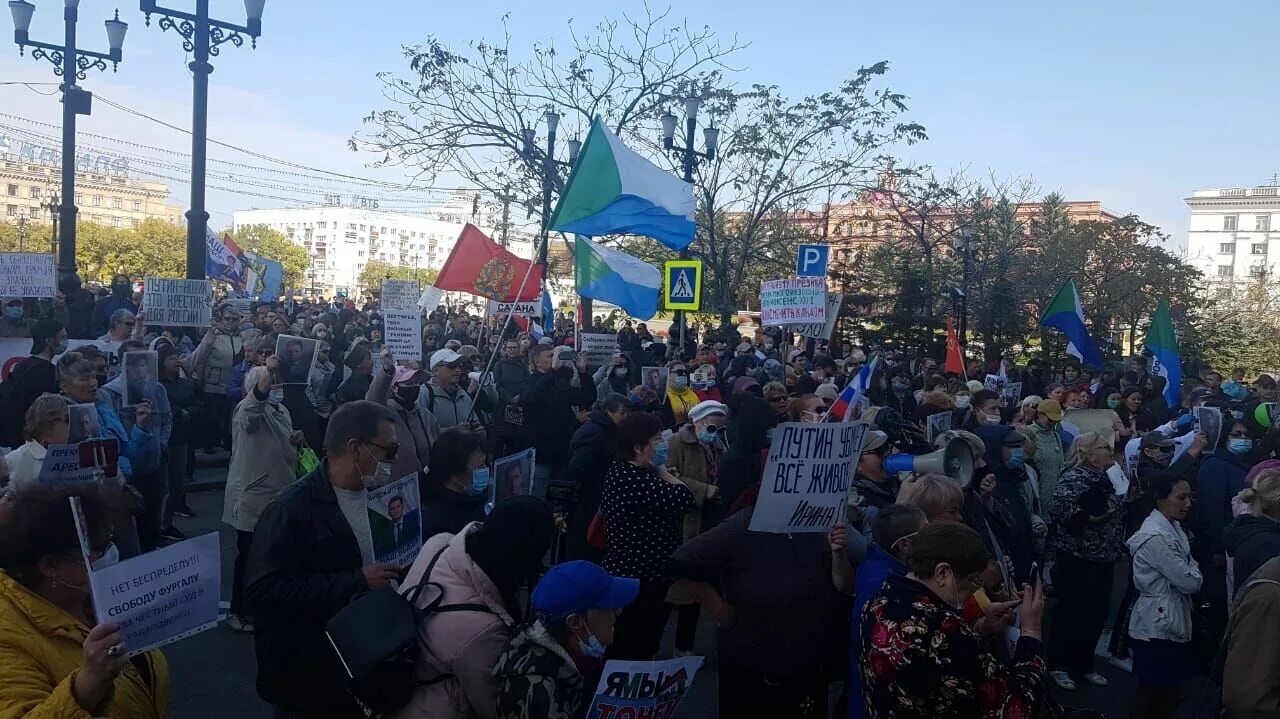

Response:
(573, 235), (662, 320)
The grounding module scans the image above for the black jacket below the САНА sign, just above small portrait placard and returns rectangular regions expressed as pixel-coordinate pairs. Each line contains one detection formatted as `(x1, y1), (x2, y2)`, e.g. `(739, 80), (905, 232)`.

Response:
(520, 370), (595, 467)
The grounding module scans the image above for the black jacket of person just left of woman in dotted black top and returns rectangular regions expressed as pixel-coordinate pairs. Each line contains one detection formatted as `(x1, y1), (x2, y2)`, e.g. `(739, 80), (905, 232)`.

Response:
(564, 408), (617, 562)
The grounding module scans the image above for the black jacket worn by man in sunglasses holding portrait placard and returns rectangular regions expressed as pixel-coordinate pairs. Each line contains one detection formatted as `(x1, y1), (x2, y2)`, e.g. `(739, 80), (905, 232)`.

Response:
(244, 459), (369, 718)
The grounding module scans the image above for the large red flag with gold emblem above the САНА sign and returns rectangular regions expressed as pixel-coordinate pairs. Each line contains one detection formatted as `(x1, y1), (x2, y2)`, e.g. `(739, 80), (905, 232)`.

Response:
(435, 224), (543, 302)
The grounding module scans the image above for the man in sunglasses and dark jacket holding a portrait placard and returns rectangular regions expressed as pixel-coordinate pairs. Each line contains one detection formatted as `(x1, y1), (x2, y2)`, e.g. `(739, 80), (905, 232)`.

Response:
(244, 400), (406, 716)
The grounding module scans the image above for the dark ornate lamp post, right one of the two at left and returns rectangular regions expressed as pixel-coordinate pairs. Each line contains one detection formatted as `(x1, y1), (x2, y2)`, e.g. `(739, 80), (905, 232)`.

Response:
(142, 0), (266, 280)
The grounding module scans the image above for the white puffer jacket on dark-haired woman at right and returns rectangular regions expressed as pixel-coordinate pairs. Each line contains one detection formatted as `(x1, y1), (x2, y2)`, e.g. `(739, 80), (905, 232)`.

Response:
(1128, 509), (1204, 642)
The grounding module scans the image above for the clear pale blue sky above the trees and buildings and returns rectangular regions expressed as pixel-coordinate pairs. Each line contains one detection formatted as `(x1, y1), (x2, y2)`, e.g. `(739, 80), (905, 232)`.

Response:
(0, 0), (1280, 244)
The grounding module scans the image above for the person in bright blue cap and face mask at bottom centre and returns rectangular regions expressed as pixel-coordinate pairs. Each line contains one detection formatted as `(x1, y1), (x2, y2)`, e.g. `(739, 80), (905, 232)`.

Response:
(493, 562), (640, 719)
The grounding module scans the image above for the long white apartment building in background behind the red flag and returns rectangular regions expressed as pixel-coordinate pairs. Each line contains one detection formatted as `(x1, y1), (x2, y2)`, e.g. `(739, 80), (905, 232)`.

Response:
(233, 207), (534, 297)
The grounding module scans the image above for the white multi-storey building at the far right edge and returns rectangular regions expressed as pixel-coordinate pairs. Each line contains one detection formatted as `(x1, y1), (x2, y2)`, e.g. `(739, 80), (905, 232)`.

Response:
(1187, 186), (1280, 297)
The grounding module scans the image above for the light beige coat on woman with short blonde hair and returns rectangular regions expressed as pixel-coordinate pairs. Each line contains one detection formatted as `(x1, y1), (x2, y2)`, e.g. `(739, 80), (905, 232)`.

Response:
(223, 367), (298, 532)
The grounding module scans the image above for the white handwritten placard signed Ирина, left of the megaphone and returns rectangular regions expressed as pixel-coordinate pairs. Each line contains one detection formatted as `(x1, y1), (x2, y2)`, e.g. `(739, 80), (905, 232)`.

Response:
(749, 422), (867, 533)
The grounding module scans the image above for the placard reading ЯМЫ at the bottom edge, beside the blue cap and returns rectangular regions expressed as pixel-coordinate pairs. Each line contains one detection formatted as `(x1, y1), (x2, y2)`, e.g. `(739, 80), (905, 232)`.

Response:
(586, 656), (703, 719)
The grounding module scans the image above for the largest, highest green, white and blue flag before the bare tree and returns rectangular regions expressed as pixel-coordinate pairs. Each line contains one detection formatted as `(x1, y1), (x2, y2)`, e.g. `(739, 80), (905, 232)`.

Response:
(552, 118), (698, 249)
